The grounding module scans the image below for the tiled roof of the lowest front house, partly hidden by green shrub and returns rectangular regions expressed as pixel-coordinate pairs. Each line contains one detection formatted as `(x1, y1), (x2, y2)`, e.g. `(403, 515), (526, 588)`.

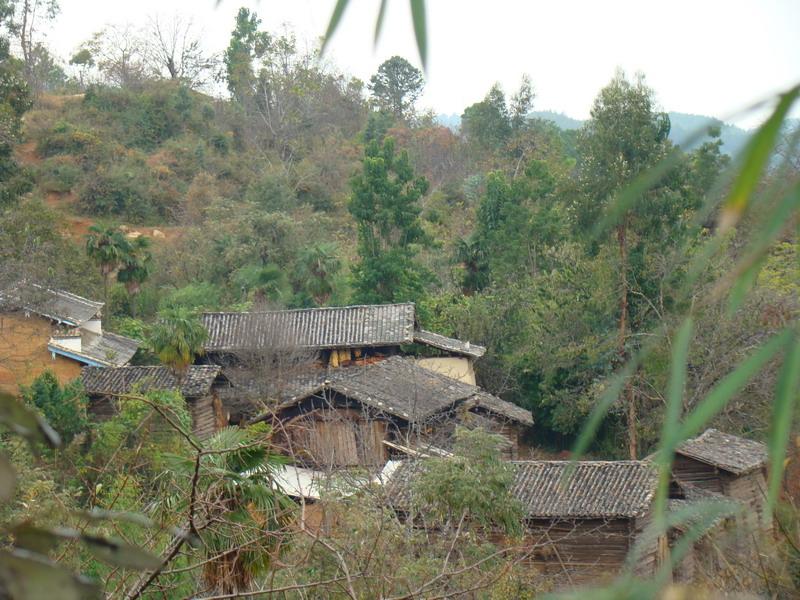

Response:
(386, 461), (657, 519)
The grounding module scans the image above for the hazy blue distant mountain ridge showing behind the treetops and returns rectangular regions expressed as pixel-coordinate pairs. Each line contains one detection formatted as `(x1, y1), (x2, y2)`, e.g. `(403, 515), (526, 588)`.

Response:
(436, 110), (751, 156)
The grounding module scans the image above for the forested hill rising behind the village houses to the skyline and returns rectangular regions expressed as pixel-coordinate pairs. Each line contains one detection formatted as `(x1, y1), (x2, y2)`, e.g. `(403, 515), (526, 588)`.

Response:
(0, 9), (800, 456)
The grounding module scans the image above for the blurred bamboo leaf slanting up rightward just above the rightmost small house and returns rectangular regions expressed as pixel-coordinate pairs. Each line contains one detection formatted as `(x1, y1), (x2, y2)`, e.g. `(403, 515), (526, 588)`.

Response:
(678, 329), (792, 440)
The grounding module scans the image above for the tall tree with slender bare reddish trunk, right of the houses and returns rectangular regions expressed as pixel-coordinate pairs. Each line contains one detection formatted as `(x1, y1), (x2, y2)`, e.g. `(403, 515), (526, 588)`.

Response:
(578, 72), (680, 458)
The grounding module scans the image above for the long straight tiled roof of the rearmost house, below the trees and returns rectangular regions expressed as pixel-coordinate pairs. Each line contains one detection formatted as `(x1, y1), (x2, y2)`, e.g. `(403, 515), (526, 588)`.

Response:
(203, 303), (414, 351)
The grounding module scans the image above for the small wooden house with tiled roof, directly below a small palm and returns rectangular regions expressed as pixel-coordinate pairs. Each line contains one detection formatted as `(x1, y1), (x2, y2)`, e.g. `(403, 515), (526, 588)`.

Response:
(81, 365), (227, 439)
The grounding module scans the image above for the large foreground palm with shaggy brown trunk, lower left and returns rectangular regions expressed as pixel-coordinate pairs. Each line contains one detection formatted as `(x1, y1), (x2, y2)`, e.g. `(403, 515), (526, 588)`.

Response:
(170, 424), (295, 596)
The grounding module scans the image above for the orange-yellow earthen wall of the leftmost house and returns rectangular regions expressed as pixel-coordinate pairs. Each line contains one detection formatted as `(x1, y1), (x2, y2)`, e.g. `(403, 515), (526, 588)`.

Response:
(0, 312), (81, 394)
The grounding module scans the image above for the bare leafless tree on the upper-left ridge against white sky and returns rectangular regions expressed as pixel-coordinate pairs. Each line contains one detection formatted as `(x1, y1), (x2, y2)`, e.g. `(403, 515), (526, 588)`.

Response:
(146, 15), (215, 89)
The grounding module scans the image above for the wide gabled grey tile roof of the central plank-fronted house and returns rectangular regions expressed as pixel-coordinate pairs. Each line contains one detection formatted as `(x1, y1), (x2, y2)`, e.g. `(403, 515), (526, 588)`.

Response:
(270, 356), (533, 425)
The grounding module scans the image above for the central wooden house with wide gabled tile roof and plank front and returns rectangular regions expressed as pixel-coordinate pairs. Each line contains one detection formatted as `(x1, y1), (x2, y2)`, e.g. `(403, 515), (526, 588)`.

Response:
(245, 356), (533, 469)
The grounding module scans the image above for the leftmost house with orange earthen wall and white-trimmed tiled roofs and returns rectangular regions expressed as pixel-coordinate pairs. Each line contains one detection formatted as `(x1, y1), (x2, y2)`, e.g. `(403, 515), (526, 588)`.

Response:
(0, 283), (139, 393)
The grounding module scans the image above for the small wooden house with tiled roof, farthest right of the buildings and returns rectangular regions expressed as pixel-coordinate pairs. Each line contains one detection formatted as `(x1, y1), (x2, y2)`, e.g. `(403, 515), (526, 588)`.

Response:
(670, 429), (772, 534)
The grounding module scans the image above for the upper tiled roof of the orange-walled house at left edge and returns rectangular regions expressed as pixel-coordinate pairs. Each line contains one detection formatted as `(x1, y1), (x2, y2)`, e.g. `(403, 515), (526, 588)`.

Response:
(0, 283), (103, 327)
